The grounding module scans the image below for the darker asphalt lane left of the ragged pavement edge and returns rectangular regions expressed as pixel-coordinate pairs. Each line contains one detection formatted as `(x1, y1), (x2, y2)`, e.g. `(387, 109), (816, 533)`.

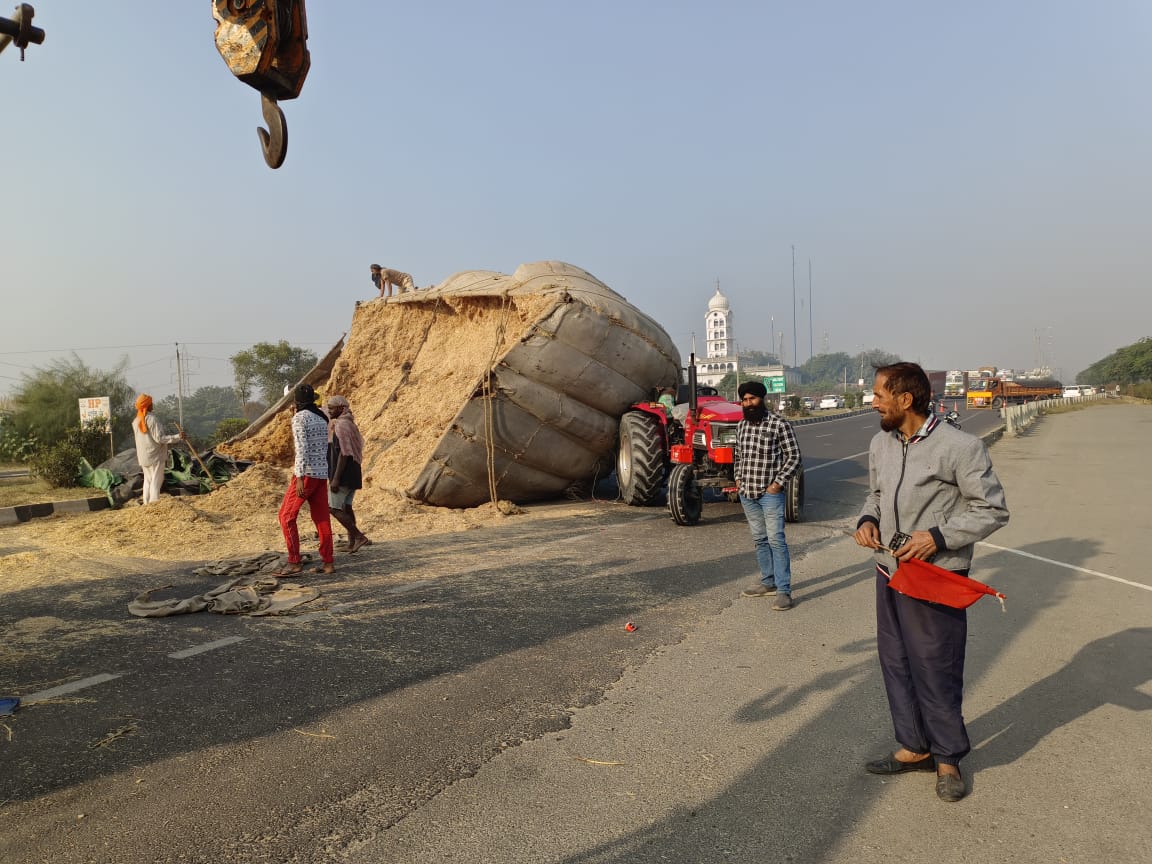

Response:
(0, 412), (1009, 864)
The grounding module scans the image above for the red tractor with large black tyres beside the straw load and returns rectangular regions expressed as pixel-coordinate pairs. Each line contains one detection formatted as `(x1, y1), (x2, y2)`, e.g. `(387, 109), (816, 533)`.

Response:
(616, 361), (804, 525)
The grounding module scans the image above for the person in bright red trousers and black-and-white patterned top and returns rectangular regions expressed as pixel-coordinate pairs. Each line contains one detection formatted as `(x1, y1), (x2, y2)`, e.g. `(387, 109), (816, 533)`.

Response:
(274, 384), (335, 576)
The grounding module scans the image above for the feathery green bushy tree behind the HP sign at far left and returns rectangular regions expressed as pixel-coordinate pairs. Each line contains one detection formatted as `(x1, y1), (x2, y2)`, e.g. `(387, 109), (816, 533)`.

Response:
(6, 354), (136, 456)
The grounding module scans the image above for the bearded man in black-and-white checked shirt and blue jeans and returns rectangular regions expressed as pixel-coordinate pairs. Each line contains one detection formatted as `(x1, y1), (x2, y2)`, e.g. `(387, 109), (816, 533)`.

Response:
(733, 381), (801, 612)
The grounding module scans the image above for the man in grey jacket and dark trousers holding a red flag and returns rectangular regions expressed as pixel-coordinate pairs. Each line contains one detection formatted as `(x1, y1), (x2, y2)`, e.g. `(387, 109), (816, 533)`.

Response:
(855, 363), (1008, 802)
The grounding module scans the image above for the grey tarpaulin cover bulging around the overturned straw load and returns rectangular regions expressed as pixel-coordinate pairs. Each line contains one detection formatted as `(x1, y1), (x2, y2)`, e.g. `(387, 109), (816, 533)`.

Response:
(397, 262), (680, 507)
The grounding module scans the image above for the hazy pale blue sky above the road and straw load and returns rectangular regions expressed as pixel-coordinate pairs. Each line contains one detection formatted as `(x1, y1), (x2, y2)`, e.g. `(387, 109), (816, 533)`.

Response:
(0, 0), (1152, 397)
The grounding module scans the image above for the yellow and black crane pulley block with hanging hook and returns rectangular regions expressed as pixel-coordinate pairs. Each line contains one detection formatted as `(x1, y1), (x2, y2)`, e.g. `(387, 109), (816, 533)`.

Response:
(212, 0), (311, 168)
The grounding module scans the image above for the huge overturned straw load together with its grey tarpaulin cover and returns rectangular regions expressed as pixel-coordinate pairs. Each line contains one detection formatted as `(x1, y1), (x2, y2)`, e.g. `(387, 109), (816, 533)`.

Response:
(221, 262), (680, 508)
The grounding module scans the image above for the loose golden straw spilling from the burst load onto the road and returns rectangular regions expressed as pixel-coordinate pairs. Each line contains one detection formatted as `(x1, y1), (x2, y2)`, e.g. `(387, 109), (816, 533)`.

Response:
(0, 277), (608, 594)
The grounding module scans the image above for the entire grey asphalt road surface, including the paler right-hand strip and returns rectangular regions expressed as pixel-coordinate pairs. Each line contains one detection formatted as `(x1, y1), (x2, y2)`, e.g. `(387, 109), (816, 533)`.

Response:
(0, 407), (1152, 864)
